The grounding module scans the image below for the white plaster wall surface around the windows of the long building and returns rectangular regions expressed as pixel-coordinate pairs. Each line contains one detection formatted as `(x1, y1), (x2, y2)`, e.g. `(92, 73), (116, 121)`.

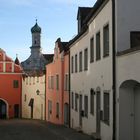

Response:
(70, 1), (112, 140)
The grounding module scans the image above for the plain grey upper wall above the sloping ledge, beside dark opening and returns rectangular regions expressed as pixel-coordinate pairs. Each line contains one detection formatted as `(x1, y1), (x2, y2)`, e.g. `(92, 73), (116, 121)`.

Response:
(116, 0), (140, 51)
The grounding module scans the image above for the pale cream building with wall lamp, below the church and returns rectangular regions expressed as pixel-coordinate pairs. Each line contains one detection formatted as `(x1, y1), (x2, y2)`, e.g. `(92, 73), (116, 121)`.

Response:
(22, 74), (46, 120)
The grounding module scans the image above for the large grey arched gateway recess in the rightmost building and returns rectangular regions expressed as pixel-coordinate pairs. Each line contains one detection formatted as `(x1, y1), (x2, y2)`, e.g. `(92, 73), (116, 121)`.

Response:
(119, 80), (140, 140)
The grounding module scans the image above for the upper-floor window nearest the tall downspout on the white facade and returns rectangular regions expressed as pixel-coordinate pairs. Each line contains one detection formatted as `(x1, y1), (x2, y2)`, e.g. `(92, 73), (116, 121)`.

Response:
(104, 25), (109, 57)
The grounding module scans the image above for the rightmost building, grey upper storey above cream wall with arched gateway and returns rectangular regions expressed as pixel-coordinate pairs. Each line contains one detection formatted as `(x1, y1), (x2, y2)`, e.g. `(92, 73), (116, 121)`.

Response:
(115, 0), (140, 140)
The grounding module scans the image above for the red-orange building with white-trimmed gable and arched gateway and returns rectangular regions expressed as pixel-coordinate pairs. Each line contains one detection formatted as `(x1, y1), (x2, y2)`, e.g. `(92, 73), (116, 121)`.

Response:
(0, 49), (22, 119)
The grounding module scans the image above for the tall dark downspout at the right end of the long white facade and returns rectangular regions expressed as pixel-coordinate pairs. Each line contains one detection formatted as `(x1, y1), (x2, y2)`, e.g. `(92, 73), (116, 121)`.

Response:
(112, 0), (116, 140)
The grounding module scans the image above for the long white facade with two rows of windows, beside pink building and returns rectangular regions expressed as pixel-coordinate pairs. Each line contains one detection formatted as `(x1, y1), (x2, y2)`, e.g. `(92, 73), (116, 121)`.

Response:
(70, 0), (113, 140)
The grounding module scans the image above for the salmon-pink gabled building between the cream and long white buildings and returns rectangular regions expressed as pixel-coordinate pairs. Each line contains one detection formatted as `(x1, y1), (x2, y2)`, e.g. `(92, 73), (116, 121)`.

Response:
(46, 38), (69, 126)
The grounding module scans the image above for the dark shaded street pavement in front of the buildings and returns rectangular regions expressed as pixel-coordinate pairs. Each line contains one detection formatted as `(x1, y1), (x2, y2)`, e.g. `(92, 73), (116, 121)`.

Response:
(0, 120), (93, 140)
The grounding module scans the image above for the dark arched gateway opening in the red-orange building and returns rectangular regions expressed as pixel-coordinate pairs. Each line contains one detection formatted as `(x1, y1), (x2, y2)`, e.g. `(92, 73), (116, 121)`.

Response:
(0, 99), (7, 119)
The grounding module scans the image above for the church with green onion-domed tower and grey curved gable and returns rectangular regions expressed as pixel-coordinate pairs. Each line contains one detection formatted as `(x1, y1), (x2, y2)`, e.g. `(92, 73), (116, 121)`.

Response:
(21, 20), (53, 75)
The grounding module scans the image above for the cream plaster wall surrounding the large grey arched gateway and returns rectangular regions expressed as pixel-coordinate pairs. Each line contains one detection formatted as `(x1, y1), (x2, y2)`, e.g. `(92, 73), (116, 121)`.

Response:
(116, 51), (140, 140)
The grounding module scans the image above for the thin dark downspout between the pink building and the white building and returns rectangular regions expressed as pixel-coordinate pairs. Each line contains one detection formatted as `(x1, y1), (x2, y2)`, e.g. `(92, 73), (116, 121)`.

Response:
(68, 49), (71, 128)
